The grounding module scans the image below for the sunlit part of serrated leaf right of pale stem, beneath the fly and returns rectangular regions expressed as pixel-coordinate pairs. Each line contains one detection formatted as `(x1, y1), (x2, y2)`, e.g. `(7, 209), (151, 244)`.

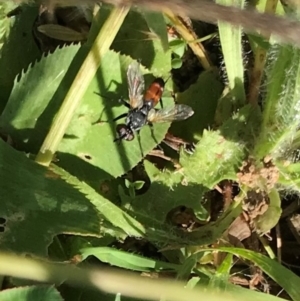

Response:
(58, 52), (174, 180)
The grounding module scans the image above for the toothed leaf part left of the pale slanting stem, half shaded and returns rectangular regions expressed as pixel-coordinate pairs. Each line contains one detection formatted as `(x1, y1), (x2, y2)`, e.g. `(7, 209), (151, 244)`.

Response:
(0, 45), (80, 153)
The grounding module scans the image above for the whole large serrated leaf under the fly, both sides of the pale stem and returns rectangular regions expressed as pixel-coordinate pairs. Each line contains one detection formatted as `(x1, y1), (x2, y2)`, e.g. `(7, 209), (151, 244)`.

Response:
(0, 45), (174, 181)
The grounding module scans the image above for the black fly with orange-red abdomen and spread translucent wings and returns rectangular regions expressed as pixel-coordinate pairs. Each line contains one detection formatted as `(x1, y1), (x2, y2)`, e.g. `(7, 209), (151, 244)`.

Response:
(114, 62), (194, 142)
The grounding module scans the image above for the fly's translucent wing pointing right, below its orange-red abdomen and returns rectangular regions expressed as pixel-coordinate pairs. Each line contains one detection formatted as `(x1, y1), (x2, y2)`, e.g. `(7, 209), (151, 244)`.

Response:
(148, 105), (194, 123)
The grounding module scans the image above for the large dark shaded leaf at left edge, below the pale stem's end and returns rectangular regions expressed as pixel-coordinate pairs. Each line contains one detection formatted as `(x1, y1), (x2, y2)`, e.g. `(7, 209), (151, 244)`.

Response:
(0, 139), (100, 256)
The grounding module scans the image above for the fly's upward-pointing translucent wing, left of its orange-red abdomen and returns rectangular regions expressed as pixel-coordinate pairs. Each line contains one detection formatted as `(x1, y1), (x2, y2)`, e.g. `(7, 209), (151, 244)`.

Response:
(127, 61), (145, 109)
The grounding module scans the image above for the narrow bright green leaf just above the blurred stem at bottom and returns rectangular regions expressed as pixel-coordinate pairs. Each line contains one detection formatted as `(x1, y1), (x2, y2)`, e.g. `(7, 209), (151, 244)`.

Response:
(81, 247), (179, 272)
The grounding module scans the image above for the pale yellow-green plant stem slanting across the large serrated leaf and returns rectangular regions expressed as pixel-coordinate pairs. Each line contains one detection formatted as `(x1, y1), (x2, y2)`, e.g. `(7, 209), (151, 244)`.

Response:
(35, 6), (129, 166)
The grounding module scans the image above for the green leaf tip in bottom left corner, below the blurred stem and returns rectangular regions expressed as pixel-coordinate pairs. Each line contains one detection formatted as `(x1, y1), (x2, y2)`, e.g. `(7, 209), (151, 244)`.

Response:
(0, 285), (63, 301)
